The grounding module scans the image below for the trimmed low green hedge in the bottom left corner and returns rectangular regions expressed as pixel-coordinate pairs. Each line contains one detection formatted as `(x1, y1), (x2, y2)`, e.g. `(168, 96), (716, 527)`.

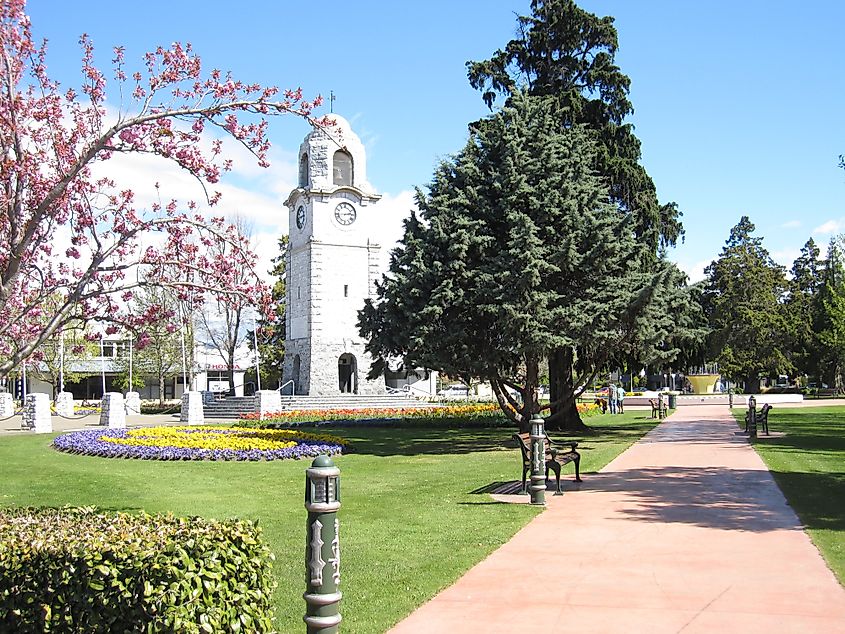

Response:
(0, 507), (274, 633)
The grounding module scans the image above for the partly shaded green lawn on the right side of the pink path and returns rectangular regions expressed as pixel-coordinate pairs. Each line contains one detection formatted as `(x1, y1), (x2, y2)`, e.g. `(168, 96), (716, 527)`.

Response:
(738, 405), (845, 585)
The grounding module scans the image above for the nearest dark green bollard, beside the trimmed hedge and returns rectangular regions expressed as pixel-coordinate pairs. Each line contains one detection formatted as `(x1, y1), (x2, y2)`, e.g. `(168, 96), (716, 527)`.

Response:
(302, 456), (342, 634)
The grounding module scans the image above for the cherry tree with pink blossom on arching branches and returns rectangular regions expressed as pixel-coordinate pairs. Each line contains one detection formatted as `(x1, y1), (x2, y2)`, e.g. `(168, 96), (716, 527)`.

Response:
(0, 0), (320, 377)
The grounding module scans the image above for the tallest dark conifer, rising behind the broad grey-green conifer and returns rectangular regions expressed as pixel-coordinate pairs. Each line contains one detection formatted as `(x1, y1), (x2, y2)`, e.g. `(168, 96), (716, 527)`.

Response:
(467, 0), (700, 418)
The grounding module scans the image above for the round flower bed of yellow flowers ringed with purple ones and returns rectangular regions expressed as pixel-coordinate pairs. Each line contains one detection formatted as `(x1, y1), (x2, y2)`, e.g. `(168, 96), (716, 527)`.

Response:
(53, 426), (347, 460)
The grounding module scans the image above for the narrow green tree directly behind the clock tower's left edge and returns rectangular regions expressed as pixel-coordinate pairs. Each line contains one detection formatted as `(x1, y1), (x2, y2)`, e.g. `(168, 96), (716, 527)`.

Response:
(245, 236), (288, 388)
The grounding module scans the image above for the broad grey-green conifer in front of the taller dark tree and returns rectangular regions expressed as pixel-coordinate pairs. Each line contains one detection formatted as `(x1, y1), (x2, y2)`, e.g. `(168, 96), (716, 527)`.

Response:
(359, 94), (696, 428)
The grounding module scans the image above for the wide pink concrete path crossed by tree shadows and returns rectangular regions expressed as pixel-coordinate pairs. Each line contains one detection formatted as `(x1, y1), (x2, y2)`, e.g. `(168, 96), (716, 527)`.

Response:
(391, 405), (845, 634)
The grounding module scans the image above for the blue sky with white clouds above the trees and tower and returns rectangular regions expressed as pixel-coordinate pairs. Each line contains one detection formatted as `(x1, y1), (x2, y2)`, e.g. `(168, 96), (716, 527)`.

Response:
(28, 0), (845, 279)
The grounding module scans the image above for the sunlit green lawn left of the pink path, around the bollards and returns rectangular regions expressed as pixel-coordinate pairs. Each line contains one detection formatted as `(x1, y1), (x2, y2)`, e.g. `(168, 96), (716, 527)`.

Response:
(0, 412), (655, 633)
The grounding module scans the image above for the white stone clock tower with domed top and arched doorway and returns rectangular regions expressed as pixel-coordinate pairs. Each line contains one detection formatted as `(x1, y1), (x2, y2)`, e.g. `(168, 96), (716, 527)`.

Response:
(283, 114), (385, 395)
